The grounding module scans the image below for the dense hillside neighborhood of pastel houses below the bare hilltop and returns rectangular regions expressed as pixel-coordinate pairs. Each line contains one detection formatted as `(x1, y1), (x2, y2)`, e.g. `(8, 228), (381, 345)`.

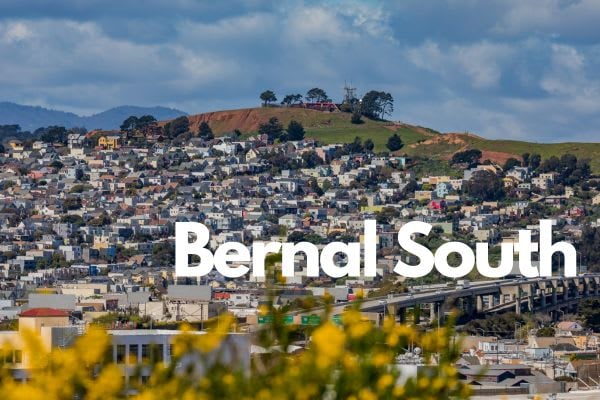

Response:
(0, 106), (600, 393)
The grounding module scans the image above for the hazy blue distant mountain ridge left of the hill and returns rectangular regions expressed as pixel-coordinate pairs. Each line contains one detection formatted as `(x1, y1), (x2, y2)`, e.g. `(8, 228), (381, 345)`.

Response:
(0, 102), (186, 131)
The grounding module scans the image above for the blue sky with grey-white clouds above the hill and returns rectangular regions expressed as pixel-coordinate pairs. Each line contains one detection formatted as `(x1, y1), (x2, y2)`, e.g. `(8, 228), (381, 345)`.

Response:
(0, 0), (600, 142)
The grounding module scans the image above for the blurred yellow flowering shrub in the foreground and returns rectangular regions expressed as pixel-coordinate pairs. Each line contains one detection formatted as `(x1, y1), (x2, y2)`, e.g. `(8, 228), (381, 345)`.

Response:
(0, 296), (468, 400)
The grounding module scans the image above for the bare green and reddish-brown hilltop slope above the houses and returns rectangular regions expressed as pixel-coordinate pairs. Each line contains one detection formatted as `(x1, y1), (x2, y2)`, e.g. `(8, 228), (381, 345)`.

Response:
(183, 107), (600, 173)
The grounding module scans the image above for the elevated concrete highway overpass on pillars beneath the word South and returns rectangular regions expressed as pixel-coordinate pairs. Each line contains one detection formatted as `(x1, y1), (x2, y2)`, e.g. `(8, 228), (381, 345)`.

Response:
(296, 273), (600, 323)
